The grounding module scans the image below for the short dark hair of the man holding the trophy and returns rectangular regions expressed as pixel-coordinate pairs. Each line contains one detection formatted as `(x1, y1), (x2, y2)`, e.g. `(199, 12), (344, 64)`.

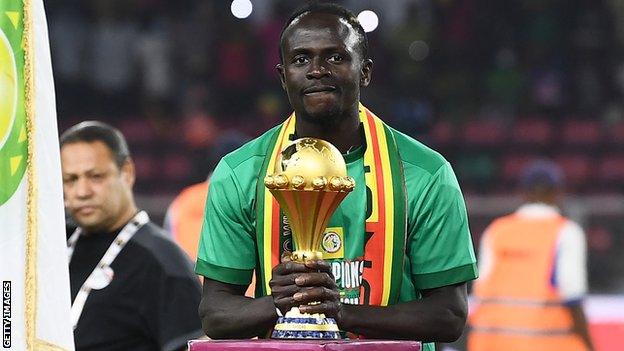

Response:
(278, 1), (368, 62)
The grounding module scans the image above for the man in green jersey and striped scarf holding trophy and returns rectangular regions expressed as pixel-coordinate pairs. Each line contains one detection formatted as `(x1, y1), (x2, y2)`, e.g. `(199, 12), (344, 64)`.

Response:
(196, 4), (477, 350)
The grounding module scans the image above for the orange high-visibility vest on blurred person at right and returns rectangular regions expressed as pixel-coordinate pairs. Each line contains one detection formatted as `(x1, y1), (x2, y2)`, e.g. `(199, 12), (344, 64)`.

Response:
(468, 214), (586, 351)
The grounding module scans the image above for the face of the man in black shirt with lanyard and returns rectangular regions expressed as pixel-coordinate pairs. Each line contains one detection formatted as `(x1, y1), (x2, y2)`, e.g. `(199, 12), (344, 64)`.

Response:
(61, 141), (134, 232)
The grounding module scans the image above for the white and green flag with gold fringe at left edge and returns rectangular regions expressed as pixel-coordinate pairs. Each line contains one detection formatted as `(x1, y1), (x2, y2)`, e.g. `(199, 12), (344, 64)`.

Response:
(0, 0), (74, 351)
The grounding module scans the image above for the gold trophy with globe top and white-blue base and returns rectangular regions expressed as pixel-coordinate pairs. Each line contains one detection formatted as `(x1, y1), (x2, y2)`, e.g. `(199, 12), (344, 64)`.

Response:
(264, 138), (355, 339)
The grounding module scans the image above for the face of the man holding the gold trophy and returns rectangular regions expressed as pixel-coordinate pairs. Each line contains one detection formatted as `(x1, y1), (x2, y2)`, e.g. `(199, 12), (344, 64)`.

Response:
(277, 13), (372, 124)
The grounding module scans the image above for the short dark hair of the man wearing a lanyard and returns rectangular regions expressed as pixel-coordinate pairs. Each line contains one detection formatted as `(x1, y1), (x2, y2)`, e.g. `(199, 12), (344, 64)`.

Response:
(60, 121), (130, 168)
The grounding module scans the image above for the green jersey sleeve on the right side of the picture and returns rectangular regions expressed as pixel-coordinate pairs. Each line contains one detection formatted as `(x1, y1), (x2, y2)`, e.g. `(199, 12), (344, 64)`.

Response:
(406, 162), (478, 290)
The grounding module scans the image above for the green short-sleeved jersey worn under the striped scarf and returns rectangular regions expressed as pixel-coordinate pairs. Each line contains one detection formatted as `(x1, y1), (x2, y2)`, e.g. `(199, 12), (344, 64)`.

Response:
(196, 127), (477, 350)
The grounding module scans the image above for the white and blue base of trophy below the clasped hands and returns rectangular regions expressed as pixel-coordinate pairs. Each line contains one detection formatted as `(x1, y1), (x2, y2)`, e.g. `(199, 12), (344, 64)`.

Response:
(271, 307), (340, 340)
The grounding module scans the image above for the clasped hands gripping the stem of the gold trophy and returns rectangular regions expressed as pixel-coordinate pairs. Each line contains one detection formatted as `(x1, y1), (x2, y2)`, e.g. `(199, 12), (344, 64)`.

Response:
(269, 252), (342, 321)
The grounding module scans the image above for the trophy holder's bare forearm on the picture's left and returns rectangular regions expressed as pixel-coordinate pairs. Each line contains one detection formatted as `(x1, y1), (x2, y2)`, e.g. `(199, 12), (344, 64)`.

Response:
(199, 284), (277, 339)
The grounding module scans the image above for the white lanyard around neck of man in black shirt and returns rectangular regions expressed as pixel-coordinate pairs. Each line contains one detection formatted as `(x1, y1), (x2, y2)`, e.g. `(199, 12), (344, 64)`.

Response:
(67, 211), (149, 329)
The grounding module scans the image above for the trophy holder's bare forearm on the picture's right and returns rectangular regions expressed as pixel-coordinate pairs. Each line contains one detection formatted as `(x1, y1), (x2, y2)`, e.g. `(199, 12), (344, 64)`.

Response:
(339, 287), (467, 342)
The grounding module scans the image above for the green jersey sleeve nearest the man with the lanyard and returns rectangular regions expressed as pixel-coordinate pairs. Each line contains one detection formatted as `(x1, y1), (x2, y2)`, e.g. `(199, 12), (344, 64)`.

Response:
(195, 161), (257, 285)
